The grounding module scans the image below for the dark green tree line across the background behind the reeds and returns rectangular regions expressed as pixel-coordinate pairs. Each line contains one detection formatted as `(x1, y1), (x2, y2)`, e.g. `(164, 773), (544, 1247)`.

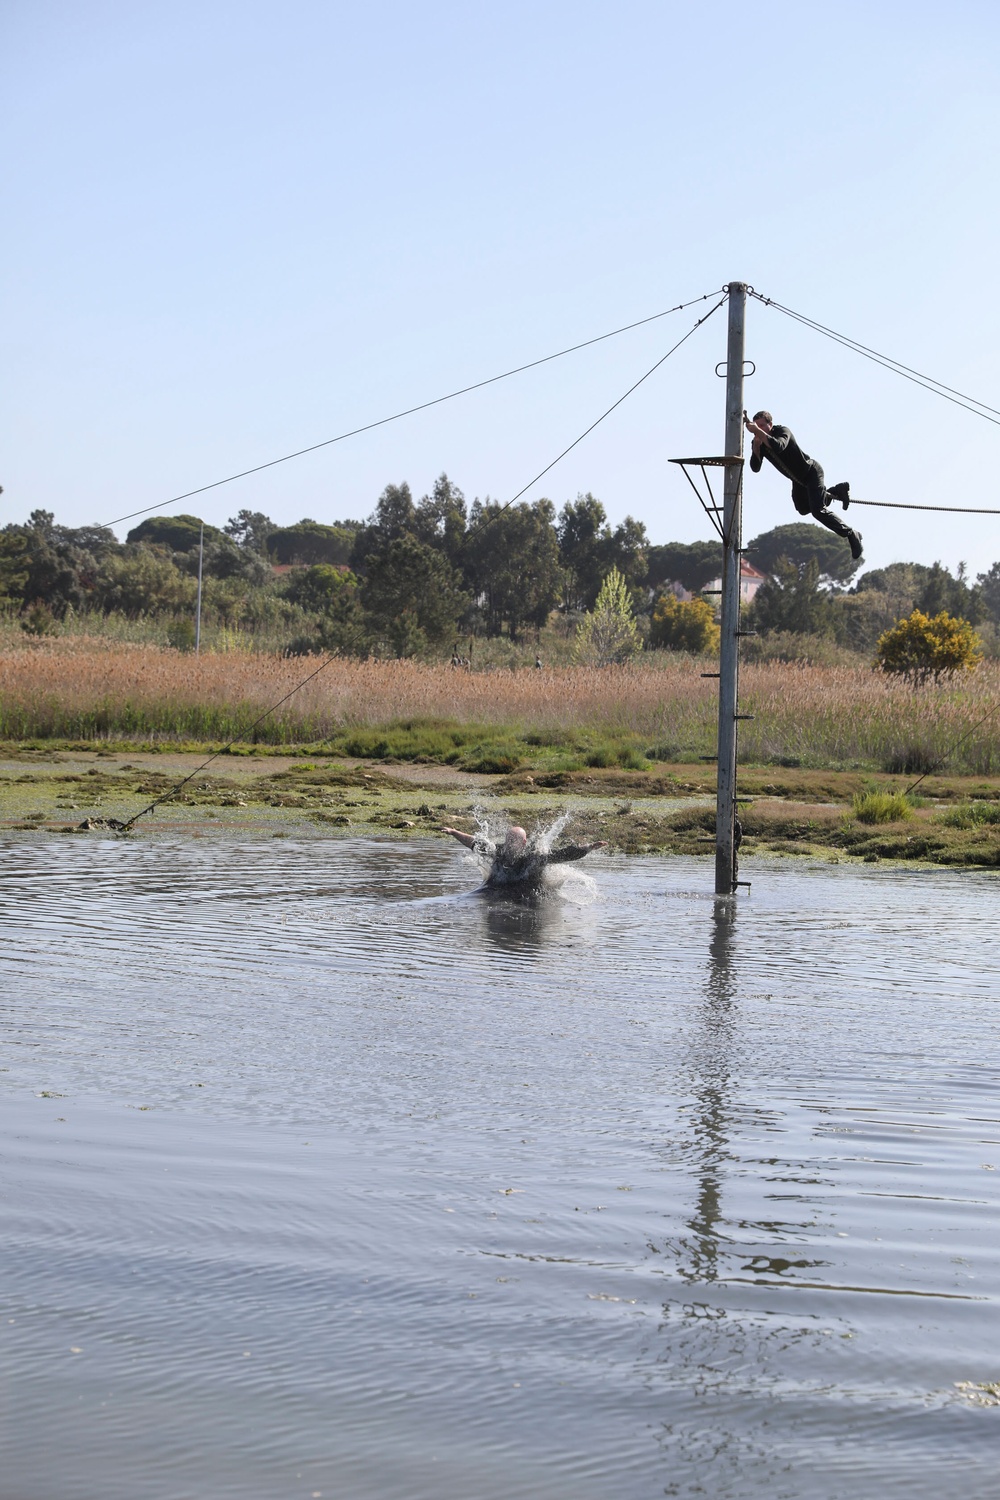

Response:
(0, 474), (1000, 656)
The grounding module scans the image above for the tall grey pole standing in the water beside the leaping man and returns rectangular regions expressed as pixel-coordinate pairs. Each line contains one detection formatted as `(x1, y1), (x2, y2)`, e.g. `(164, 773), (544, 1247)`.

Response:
(715, 282), (747, 896)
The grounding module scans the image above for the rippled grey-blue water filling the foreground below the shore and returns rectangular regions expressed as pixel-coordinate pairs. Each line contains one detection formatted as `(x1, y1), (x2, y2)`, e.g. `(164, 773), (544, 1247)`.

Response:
(0, 839), (1000, 1500)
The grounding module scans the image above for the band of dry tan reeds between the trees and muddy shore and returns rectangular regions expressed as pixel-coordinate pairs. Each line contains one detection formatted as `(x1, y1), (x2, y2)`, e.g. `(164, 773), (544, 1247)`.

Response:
(0, 638), (1000, 774)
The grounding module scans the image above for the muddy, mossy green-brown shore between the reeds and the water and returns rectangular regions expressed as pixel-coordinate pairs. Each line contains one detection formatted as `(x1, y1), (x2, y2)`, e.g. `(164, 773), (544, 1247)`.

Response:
(0, 744), (1000, 869)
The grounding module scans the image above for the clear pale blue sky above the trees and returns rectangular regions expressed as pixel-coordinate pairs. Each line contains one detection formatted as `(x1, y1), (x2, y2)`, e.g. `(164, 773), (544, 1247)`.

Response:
(0, 0), (1000, 573)
